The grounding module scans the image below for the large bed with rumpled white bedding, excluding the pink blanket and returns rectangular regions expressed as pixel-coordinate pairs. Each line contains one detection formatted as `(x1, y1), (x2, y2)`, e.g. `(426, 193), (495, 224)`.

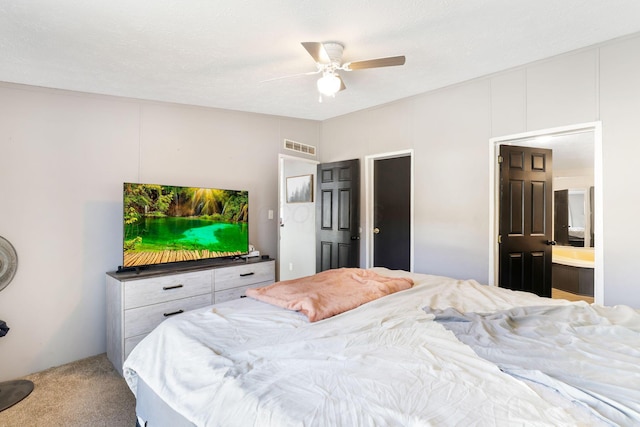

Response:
(124, 268), (640, 427)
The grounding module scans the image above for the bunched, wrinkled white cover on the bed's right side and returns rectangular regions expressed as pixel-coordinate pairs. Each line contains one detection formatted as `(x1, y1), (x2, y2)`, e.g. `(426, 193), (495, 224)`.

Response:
(425, 303), (640, 426)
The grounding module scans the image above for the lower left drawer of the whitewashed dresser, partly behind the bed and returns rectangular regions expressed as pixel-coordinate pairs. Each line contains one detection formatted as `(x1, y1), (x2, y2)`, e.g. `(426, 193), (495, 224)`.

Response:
(124, 293), (212, 339)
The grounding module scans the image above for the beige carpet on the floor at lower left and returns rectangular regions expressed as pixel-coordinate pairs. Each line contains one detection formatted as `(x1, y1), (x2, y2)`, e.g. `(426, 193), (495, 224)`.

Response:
(0, 354), (136, 427)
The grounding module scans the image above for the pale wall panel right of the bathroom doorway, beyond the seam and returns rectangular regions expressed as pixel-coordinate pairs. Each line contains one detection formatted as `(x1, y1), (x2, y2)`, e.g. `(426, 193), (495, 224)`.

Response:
(596, 37), (640, 308)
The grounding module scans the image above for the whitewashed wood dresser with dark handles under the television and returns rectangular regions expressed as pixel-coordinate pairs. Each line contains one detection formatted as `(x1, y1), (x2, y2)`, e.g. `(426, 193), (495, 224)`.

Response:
(106, 259), (275, 375)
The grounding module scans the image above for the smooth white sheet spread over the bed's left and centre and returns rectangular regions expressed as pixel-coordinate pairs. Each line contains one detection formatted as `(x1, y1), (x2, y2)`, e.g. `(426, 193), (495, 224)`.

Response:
(124, 269), (594, 426)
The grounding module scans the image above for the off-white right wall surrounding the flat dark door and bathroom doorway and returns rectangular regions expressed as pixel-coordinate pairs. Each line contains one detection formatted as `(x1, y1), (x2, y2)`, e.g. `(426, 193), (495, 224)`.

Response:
(321, 32), (640, 308)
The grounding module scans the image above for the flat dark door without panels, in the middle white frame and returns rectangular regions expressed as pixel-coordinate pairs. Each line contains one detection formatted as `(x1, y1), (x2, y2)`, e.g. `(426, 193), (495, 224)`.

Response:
(373, 156), (411, 271)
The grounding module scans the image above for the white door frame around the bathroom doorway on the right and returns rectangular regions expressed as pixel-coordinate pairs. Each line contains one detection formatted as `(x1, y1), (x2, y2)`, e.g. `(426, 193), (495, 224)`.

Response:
(489, 121), (605, 304)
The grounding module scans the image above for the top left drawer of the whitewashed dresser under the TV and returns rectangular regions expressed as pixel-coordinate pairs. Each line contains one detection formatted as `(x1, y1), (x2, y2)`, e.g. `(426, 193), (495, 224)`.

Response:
(124, 270), (212, 310)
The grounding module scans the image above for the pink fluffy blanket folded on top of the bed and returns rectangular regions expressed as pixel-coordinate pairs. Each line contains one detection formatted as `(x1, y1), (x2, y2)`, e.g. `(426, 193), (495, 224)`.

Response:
(246, 268), (413, 322)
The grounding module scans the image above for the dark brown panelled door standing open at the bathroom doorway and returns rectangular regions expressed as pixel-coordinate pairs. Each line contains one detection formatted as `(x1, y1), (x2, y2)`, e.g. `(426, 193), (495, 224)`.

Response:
(498, 145), (554, 297)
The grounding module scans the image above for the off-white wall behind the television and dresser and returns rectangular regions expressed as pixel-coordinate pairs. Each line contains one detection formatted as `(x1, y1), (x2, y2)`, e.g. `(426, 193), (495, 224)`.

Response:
(0, 84), (319, 381)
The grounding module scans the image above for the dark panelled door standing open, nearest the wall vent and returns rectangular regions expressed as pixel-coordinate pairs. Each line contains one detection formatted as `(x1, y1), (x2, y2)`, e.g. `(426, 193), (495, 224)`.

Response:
(316, 159), (360, 272)
